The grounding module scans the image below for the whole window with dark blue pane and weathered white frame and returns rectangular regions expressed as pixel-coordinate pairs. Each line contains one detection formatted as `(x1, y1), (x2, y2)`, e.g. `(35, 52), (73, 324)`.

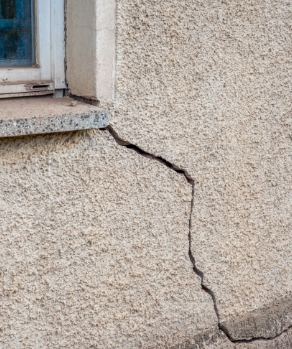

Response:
(0, 0), (66, 98)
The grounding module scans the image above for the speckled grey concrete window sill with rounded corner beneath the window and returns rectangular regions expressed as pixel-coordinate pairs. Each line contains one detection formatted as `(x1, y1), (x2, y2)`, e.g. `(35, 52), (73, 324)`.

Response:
(0, 97), (109, 138)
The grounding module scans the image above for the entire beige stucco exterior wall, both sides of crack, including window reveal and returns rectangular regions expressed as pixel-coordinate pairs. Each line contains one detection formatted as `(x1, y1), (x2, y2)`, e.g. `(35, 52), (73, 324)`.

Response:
(0, 0), (292, 349)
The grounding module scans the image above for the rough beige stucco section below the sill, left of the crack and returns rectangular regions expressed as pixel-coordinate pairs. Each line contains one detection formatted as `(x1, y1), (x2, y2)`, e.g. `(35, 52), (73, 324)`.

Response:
(0, 131), (217, 349)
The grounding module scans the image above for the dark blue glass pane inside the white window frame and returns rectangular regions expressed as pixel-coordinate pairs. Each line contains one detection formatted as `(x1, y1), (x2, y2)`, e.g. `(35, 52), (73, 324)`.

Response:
(0, 0), (35, 67)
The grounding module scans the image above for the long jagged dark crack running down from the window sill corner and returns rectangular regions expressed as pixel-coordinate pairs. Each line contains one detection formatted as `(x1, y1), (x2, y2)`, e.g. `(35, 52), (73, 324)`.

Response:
(104, 125), (292, 344)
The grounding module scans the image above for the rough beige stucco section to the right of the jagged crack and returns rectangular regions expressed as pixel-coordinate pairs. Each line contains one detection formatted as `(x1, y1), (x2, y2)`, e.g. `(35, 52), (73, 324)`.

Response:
(112, 0), (292, 339)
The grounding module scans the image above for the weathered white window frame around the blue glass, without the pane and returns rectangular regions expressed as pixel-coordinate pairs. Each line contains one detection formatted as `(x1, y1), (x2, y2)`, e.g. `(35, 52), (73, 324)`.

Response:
(0, 0), (67, 98)
